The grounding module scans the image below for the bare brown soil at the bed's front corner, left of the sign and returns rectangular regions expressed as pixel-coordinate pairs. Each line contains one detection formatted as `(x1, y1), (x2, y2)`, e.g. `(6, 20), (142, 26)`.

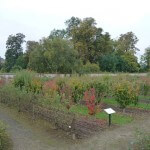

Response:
(25, 105), (108, 138)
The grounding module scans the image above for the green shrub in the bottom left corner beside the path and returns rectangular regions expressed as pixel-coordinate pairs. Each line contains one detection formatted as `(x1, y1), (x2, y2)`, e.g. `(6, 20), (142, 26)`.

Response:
(0, 121), (12, 150)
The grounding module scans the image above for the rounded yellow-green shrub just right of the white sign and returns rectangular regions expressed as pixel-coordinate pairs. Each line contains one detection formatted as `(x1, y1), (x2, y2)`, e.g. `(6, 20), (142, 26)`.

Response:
(114, 80), (139, 109)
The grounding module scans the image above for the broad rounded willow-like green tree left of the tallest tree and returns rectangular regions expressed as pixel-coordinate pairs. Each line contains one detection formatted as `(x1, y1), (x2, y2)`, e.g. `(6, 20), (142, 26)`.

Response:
(28, 38), (79, 73)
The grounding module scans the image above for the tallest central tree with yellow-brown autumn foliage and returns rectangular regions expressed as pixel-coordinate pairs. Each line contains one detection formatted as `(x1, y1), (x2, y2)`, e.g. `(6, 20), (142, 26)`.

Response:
(72, 18), (97, 64)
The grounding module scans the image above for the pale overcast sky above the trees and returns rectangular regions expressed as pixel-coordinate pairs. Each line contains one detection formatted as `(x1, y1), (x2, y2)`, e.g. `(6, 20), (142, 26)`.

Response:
(0, 0), (150, 57)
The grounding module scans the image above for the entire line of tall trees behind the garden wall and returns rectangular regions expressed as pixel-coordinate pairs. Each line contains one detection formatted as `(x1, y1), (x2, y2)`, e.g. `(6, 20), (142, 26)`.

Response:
(0, 17), (150, 74)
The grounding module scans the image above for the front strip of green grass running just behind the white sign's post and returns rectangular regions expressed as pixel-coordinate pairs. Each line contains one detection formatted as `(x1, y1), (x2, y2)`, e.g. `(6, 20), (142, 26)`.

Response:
(70, 105), (133, 125)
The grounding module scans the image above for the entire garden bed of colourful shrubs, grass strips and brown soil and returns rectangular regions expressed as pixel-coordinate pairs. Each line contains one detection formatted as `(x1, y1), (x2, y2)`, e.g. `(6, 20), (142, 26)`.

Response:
(0, 71), (150, 137)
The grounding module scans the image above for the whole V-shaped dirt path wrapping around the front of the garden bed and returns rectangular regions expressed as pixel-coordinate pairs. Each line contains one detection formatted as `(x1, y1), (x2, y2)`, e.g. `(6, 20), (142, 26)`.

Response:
(0, 106), (150, 150)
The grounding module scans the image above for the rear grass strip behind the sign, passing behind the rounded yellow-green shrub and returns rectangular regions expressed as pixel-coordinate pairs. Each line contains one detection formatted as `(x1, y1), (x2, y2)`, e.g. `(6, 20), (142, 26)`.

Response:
(103, 98), (150, 110)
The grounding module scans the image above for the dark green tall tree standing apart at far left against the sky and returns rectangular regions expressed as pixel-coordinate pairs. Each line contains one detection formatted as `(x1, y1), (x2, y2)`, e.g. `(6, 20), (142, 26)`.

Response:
(5, 33), (25, 72)
